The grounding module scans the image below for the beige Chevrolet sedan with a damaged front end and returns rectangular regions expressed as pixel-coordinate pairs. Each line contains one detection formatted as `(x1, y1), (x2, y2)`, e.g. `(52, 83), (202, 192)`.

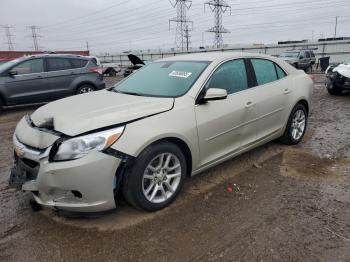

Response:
(10, 52), (313, 212)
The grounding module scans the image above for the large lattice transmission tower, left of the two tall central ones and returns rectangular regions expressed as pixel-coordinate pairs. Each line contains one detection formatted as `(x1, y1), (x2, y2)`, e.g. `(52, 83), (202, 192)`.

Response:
(169, 0), (193, 50)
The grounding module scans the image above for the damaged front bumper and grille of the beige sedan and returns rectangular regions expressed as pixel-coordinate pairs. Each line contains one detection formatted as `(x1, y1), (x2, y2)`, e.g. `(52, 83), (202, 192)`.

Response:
(9, 117), (131, 212)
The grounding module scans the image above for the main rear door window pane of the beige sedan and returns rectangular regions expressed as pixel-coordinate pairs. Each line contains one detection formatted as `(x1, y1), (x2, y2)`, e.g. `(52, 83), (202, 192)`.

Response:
(251, 58), (278, 85)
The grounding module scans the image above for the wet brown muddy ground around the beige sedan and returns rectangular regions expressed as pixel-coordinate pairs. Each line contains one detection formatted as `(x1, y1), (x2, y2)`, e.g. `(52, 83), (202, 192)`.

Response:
(0, 76), (350, 261)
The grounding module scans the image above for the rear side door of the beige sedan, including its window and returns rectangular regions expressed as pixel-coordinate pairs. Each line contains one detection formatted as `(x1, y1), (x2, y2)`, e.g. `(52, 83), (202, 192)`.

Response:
(250, 58), (293, 140)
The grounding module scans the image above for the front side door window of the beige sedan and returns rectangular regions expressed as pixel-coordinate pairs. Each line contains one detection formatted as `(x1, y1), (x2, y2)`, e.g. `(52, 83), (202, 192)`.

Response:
(206, 59), (248, 94)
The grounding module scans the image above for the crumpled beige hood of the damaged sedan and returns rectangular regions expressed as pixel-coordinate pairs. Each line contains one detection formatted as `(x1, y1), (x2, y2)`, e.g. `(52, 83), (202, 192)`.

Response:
(31, 90), (174, 136)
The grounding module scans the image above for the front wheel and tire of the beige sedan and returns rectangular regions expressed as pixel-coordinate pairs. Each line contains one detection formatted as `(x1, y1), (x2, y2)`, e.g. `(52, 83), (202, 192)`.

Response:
(122, 142), (187, 211)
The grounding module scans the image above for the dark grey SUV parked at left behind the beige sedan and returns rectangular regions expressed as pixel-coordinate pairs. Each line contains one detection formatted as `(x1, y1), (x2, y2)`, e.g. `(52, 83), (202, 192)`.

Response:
(0, 54), (105, 111)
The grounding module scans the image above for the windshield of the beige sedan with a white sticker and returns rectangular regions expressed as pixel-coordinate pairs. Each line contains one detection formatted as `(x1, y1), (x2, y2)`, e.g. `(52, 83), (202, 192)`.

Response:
(112, 61), (209, 97)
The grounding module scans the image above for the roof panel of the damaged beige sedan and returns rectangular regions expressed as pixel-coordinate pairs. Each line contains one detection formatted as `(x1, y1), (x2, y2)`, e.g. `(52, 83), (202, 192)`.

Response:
(157, 52), (272, 62)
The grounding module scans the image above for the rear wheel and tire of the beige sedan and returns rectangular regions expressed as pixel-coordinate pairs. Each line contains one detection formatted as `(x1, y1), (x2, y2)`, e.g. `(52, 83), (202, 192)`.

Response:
(279, 104), (308, 145)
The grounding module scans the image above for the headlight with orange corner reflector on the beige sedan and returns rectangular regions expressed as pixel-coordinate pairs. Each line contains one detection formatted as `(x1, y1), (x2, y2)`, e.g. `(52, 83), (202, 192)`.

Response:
(53, 126), (125, 161)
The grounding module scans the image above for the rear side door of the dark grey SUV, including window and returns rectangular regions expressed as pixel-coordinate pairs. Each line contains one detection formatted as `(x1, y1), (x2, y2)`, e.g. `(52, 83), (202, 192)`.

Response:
(45, 57), (77, 100)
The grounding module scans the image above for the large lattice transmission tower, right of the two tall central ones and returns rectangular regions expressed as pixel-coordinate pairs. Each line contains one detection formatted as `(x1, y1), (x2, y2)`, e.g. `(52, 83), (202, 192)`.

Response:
(204, 0), (231, 48)
